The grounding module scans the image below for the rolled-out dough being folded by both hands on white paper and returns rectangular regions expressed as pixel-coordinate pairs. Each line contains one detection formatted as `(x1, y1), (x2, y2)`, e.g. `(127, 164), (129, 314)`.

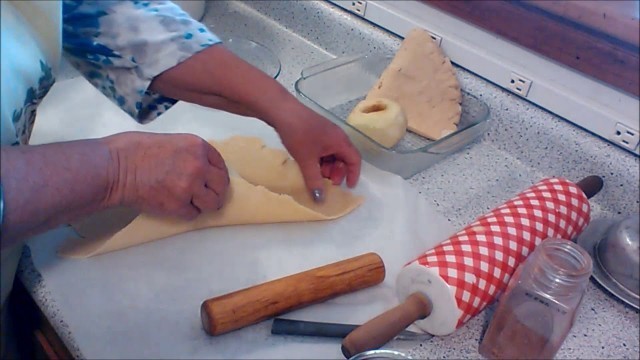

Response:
(59, 136), (364, 258)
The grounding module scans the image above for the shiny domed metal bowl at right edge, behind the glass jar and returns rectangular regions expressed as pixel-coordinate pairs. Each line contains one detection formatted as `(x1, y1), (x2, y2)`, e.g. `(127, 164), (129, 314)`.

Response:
(594, 214), (640, 297)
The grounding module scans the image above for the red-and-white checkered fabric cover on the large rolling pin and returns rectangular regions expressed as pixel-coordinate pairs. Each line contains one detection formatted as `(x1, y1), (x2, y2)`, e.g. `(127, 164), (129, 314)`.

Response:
(411, 178), (590, 328)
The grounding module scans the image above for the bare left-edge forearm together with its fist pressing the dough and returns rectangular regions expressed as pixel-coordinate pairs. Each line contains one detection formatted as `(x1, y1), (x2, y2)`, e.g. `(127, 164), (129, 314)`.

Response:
(0, 132), (229, 249)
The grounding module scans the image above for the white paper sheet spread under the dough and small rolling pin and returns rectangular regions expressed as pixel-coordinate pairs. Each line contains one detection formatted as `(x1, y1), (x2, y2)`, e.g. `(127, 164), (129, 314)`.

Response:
(29, 79), (455, 359)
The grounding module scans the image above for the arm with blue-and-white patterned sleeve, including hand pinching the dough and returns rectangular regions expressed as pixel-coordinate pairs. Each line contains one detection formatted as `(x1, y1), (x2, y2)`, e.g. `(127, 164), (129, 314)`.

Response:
(63, 0), (361, 200)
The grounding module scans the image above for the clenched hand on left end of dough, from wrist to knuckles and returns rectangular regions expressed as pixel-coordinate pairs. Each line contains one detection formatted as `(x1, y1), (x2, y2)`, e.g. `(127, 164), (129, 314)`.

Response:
(102, 132), (229, 220)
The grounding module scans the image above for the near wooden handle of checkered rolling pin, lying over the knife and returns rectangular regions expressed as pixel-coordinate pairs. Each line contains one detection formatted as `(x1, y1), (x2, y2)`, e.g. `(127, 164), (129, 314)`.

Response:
(342, 292), (432, 359)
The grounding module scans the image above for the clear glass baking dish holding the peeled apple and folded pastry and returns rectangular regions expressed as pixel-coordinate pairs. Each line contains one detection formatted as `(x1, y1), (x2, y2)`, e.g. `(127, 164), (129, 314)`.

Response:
(295, 55), (489, 179)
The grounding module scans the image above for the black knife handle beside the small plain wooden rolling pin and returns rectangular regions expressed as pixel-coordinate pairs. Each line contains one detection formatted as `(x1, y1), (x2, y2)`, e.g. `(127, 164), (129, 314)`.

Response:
(271, 318), (357, 338)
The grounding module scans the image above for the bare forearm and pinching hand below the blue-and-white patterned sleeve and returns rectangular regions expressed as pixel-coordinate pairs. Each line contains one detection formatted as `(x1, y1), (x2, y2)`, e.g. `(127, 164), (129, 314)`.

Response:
(150, 44), (361, 200)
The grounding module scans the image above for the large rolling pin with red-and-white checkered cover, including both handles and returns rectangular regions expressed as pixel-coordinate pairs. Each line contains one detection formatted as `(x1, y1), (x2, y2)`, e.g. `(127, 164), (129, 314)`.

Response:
(342, 176), (603, 358)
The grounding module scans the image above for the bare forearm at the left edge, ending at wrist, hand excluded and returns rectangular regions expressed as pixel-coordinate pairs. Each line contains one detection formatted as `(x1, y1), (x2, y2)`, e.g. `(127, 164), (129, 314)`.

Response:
(0, 140), (115, 245)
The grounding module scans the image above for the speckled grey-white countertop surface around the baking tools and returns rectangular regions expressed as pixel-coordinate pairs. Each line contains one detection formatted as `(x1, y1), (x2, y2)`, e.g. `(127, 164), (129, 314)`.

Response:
(19, 1), (640, 359)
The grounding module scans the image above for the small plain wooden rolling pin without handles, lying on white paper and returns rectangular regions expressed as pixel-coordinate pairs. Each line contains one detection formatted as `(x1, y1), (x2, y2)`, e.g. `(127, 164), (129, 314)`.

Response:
(200, 253), (385, 335)
